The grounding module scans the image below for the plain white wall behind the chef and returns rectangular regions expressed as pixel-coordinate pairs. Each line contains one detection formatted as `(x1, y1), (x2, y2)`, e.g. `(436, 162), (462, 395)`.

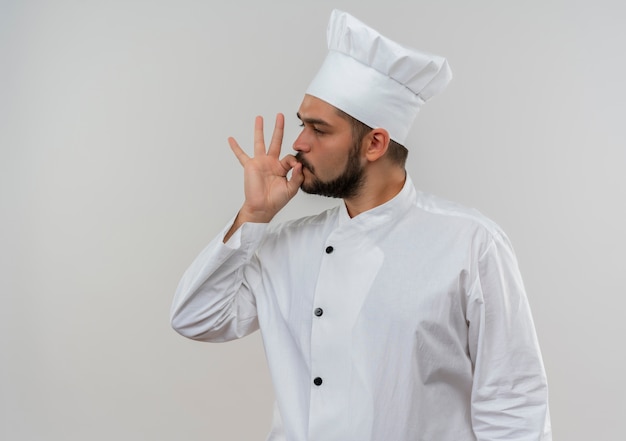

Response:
(0, 0), (626, 441)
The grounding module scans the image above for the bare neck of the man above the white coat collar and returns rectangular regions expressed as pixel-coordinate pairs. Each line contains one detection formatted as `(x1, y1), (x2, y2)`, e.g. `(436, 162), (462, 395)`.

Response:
(344, 167), (406, 218)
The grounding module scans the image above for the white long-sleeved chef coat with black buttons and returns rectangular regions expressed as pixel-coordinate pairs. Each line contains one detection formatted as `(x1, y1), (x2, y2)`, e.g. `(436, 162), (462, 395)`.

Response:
(172, 177), (551, 441)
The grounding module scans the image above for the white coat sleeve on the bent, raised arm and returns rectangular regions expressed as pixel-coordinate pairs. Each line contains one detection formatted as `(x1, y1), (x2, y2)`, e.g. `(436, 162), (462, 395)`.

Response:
(171, 224), (267, 342)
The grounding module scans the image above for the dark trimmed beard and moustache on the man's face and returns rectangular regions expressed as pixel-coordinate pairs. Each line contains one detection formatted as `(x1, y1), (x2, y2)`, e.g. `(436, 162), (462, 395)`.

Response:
(296, 142), (365, 199)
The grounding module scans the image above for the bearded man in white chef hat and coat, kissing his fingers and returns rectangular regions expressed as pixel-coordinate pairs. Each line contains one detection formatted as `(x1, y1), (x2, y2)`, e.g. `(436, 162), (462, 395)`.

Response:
(172, 11), (551, 441)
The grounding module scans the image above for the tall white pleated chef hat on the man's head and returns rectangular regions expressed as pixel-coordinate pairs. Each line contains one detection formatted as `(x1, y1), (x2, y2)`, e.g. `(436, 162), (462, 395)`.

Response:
(306, 9), (452, 144)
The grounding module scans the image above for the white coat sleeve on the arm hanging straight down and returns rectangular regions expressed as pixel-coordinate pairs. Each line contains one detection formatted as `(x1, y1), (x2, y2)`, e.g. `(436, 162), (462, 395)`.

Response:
(467, 234), (552, 441)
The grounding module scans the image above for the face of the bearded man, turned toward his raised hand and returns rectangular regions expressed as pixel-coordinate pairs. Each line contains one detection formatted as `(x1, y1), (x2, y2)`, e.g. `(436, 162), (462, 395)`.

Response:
(293, 95), (364, 198)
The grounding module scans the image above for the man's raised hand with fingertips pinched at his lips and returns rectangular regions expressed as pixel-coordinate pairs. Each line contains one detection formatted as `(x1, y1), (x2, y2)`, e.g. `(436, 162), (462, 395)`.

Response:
(224, 113), (304, 242)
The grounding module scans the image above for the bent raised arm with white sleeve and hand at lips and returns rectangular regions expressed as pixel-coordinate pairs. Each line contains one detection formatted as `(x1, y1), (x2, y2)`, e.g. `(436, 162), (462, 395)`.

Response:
(171, 114), (303, 341)
